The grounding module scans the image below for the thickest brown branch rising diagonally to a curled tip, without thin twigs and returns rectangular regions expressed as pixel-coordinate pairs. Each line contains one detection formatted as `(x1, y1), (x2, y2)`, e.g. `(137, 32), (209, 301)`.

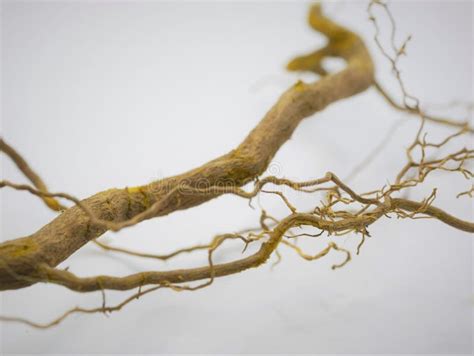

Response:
(0, 6), (374, 290)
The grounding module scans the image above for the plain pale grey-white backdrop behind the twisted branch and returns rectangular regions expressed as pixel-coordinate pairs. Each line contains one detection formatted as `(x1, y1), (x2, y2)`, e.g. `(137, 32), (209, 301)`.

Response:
(0, 1), (473, 354)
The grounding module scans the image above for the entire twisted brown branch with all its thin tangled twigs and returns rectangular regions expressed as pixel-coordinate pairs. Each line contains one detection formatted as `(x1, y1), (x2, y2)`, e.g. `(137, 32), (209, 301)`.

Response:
(0, 0), (474, 328)
